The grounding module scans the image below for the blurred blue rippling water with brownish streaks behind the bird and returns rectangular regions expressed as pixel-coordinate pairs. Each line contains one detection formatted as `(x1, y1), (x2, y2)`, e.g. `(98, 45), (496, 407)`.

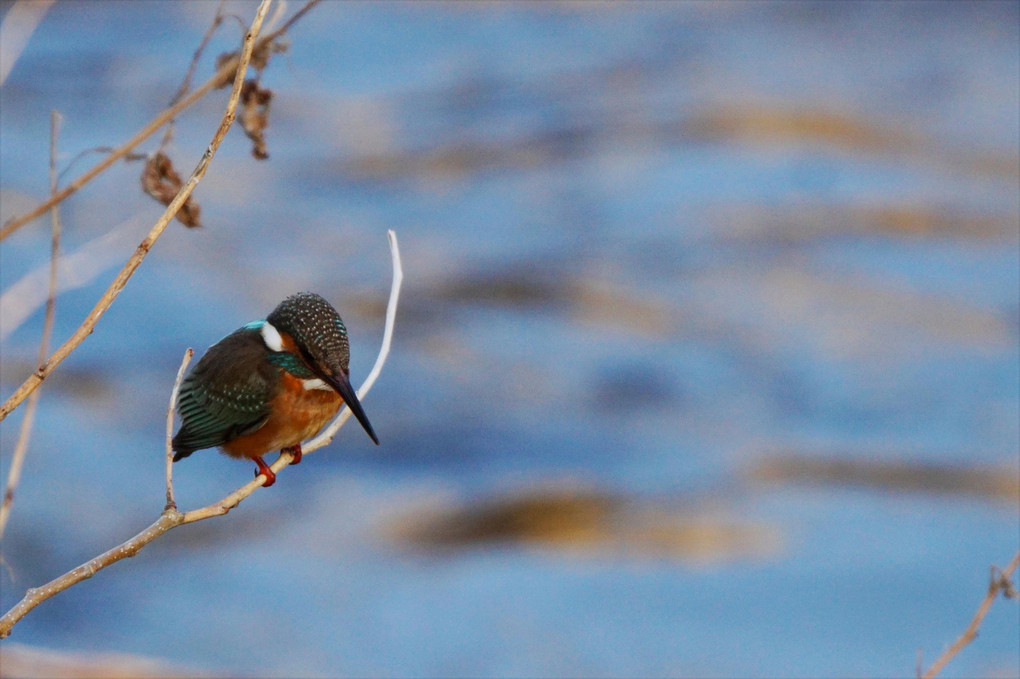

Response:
(0, 1), (1020, 677)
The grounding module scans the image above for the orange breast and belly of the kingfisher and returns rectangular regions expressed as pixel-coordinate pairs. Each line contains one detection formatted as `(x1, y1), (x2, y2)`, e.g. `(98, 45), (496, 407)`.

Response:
(222, 371), (344, 458)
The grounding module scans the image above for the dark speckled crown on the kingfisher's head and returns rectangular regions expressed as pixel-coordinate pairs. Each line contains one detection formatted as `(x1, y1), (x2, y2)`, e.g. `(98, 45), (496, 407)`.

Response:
(266, 293), (351, 373)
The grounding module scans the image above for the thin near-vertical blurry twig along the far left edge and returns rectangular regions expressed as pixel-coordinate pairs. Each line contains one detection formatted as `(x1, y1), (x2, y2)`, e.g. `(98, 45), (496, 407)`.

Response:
(0, 111), (61, 539)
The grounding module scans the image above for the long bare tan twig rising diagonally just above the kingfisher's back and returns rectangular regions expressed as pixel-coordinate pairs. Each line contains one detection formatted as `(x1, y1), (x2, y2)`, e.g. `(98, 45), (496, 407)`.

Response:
(0, 0), (272, 421)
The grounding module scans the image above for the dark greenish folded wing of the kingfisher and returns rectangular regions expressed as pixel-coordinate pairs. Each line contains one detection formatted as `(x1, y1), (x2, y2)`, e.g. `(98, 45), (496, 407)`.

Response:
(173, 328), (278, 459)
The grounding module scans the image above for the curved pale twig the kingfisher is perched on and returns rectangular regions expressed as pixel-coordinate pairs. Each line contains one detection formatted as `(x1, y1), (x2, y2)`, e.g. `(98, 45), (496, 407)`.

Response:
(0, 230), (403, 638)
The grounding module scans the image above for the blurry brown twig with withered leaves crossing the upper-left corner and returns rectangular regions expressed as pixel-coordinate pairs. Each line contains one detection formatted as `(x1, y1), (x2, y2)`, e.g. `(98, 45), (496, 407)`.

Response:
(0, 0), (321, 241)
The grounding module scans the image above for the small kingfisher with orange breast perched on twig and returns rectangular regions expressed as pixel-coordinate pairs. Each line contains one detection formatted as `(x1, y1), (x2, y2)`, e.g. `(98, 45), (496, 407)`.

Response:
(171, 293), (379, 487)
